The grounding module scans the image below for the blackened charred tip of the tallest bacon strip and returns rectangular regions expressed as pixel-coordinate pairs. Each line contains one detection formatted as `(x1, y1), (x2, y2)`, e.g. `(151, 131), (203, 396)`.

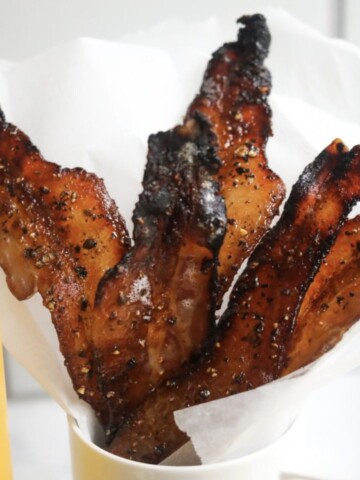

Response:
(237, 13), (271, 63)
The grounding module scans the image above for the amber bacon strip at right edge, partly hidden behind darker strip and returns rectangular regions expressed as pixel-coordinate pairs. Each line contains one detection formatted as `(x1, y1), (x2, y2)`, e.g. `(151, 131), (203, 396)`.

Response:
(283, 216), (360, 375)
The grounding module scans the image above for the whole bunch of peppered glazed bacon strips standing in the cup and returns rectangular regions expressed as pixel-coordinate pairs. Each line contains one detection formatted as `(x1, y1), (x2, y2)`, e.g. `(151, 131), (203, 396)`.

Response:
(0, 15), (360, 463)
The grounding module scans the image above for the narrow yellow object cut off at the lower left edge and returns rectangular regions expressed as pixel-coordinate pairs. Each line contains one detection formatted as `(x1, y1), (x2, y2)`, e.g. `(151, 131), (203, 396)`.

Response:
(0, 332), (12, 480)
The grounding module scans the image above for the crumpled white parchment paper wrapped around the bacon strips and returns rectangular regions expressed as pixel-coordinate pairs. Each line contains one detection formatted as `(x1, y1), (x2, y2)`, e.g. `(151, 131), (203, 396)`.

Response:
(0, 10), (360, 464)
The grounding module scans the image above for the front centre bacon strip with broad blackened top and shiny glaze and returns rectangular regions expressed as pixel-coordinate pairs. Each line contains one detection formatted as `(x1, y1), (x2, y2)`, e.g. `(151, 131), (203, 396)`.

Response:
(93, 120), (226, 435)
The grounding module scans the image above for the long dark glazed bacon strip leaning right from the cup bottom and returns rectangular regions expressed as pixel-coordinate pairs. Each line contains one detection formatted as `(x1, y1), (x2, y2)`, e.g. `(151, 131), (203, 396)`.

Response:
(109, 140), (360, 463)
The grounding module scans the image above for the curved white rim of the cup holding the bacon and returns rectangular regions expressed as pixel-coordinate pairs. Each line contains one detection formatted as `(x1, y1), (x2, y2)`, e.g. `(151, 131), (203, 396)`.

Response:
(67, 415), (286, 473)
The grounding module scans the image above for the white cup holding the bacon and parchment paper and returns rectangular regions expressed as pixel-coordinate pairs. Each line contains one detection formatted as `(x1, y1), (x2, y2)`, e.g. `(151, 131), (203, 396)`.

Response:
(68, 417), (282, 480)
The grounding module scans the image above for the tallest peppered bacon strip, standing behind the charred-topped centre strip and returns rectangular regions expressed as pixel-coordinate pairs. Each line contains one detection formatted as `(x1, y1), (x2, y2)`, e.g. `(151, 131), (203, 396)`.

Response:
(186, 15), (285, 304)
